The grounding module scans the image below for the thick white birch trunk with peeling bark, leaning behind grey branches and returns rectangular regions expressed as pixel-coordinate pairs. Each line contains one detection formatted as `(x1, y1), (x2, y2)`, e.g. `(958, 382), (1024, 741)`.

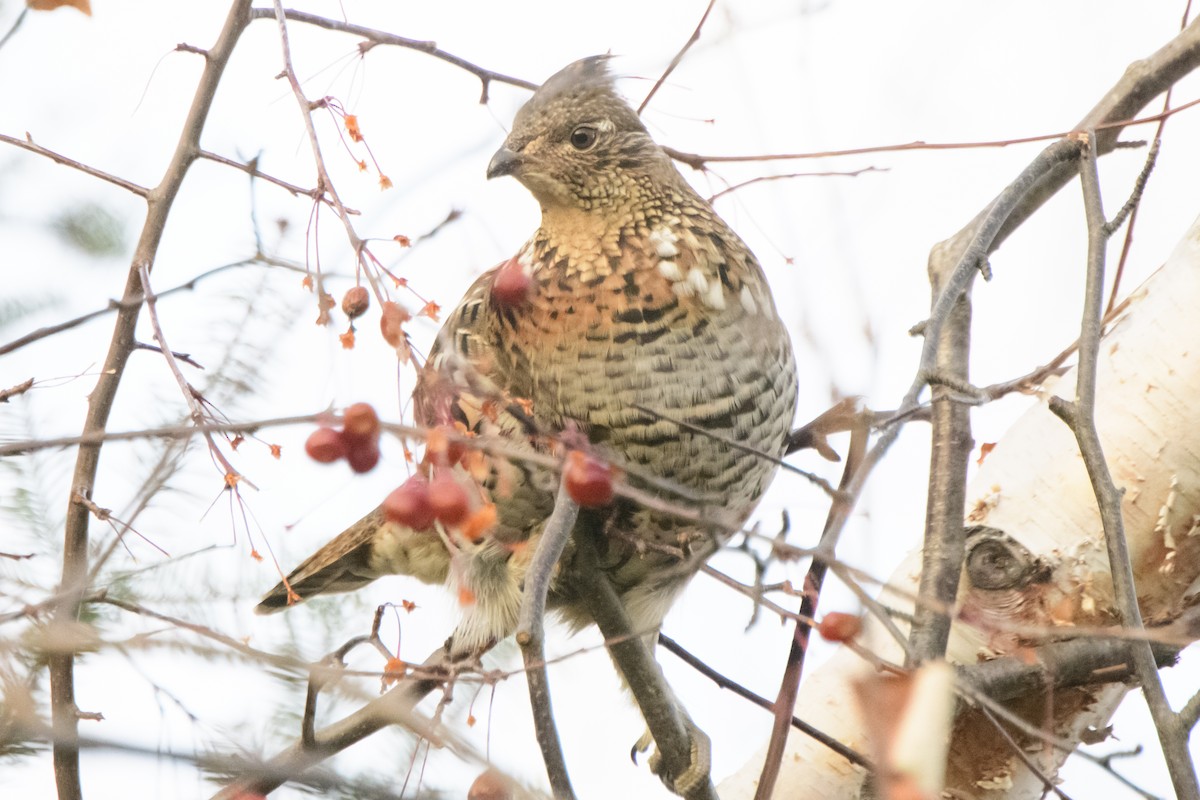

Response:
(720, 214), (1200, 800)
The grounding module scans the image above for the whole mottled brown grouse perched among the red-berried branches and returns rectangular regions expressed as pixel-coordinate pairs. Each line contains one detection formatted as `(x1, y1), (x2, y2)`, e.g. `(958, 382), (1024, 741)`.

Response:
(259, 56), (796, 652)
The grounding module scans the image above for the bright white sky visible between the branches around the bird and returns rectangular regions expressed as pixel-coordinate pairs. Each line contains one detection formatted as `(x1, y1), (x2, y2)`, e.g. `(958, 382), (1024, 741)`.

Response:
(0, 0), (1200, 798)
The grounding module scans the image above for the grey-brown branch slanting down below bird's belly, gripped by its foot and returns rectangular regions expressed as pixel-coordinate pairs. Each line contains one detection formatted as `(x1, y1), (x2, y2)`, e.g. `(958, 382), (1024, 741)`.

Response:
(571, 513), (716, 800)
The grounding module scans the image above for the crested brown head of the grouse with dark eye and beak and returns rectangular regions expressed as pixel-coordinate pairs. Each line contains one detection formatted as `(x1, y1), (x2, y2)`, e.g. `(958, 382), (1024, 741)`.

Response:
(487, 55), (674, 211)
